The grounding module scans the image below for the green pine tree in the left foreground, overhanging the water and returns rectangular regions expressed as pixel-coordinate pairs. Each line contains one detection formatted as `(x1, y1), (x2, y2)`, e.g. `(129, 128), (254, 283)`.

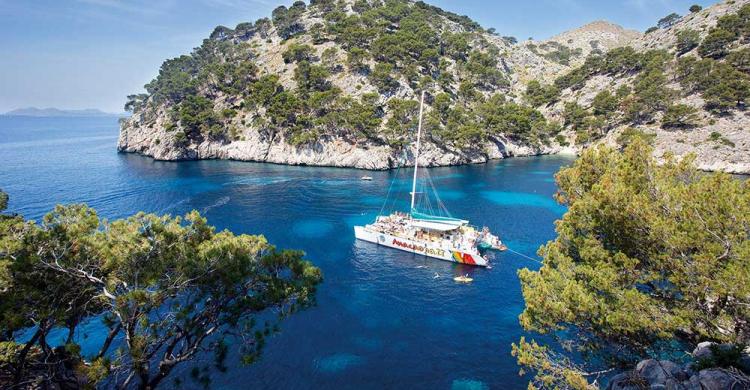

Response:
(0, 190), (321, 389)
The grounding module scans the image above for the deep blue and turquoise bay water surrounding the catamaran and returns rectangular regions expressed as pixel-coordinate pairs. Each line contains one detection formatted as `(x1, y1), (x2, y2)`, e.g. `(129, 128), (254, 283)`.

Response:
(0, 117), (572, 389)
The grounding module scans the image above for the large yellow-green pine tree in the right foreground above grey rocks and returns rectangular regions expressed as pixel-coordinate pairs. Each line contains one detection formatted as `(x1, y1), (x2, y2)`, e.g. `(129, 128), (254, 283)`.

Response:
(513, 139), (750, 388)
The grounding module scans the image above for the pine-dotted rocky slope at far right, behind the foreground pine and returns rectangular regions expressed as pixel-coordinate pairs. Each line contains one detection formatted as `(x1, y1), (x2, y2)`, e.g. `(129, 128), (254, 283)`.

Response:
(526, 4), (750, 169)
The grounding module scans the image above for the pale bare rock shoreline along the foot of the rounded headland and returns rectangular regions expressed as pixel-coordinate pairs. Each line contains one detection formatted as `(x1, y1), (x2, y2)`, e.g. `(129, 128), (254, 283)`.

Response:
(117, 123), (577, 170)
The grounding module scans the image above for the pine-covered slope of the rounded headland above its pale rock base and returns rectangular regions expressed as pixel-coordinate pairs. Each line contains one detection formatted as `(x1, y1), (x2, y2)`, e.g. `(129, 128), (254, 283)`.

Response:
(123, 0), (559, 151)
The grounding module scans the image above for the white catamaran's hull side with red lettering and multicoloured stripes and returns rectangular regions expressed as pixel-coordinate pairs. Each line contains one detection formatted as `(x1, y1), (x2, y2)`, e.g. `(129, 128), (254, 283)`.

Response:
(354, 226), (488, 267)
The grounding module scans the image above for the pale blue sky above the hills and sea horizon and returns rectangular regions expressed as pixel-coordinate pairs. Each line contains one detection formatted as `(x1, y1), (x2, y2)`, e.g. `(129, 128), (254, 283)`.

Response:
(0, 0), (713, 112)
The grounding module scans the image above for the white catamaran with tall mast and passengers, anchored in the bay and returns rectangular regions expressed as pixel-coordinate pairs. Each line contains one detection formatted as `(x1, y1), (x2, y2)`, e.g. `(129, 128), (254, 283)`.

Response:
(354, 91), (507, 267)
